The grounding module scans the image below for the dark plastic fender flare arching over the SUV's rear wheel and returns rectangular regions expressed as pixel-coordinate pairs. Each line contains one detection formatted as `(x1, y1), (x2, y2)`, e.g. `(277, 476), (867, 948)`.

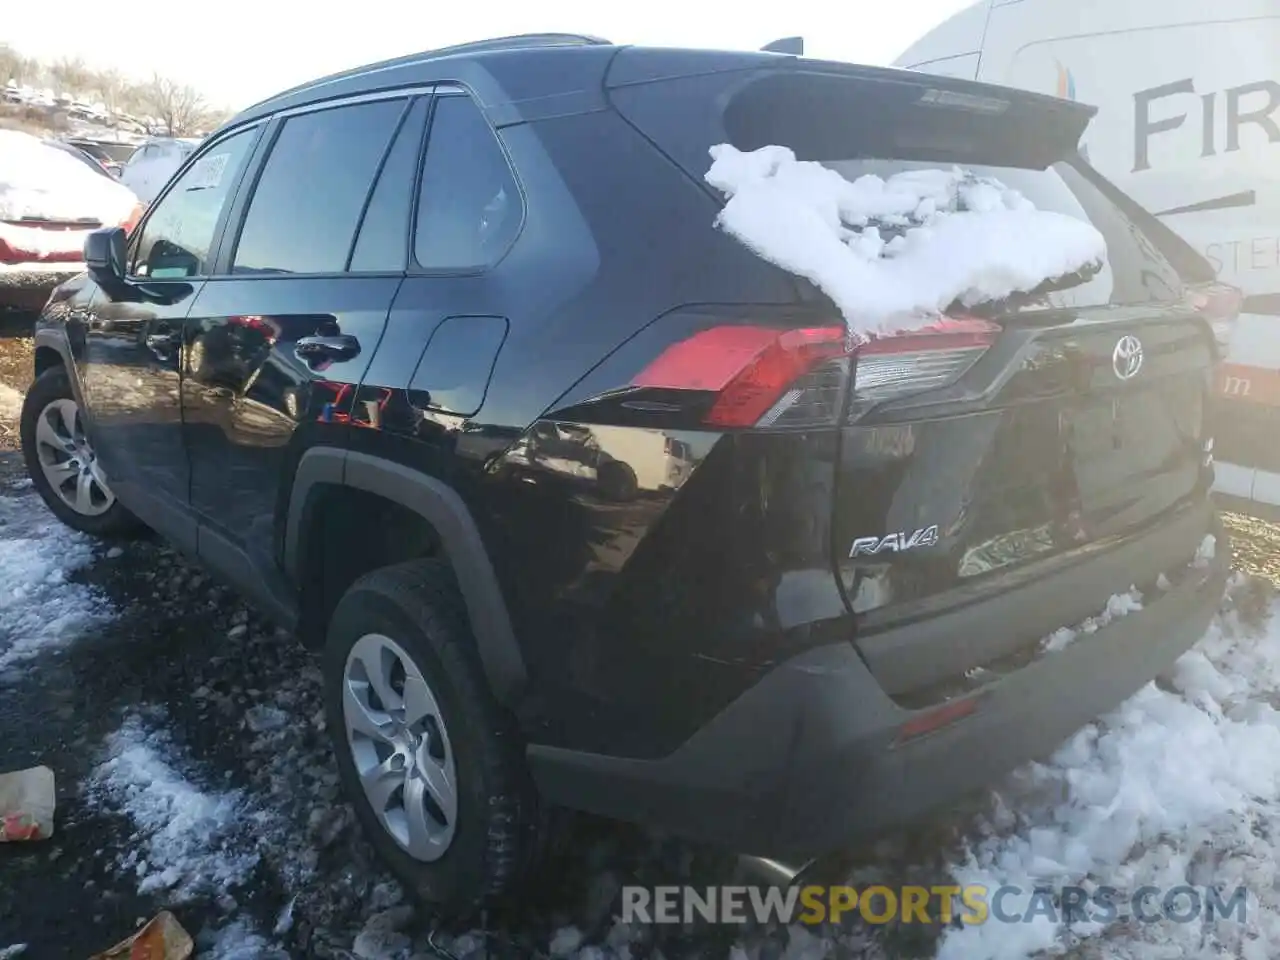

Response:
(283, 447), (527, 707)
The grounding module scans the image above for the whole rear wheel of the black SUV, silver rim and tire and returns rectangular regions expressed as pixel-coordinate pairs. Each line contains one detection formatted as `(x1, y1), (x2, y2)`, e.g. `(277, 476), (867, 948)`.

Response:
(325, 561), (540, 915)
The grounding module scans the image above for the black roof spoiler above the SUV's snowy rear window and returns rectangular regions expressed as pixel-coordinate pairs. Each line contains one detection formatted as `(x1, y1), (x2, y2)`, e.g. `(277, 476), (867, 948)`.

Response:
(605, 47), (1097, 172)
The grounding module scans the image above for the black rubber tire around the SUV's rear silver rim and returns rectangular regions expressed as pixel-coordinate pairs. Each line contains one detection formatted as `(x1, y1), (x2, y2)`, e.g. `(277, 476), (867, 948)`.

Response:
(324, 559), (544, 919)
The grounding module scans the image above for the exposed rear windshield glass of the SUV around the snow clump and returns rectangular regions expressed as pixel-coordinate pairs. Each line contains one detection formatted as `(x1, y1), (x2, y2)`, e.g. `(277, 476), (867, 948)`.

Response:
(823, 160), (1190, 308)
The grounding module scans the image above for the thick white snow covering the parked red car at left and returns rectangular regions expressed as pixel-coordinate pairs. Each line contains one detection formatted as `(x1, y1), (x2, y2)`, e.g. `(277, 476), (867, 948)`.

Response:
(0, 131), (138, 227)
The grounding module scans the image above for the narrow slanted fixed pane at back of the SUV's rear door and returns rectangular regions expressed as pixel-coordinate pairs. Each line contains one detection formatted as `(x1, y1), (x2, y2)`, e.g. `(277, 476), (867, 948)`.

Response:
(351, 97), (429, 270)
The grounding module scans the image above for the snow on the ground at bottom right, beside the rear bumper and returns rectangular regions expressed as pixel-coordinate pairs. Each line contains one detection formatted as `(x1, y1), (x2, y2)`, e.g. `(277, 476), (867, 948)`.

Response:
(937, 586), (1280, 960)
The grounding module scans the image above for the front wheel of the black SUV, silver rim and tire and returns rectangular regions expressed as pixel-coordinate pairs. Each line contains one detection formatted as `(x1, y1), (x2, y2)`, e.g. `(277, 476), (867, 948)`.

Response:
(20, 366), (141, 536)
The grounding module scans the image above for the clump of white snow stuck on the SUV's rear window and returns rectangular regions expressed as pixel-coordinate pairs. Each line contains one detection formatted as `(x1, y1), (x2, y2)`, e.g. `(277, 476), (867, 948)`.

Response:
(707, 143), (1106, 334)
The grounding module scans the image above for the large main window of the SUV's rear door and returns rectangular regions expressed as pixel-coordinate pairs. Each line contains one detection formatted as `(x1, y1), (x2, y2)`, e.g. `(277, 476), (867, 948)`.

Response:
(232, 100), (406, 274)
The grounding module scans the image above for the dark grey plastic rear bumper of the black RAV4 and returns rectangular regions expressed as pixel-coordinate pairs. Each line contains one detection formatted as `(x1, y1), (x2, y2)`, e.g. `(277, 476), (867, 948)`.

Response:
(529, 506), (1229, 859)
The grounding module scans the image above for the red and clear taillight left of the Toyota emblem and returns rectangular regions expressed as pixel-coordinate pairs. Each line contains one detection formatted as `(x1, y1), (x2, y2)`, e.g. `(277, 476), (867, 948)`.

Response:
(631, 317), (1000, 428)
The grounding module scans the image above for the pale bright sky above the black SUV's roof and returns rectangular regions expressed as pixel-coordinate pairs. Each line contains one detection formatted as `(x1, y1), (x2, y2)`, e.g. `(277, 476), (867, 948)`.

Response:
(0, 0), (970, 109)
